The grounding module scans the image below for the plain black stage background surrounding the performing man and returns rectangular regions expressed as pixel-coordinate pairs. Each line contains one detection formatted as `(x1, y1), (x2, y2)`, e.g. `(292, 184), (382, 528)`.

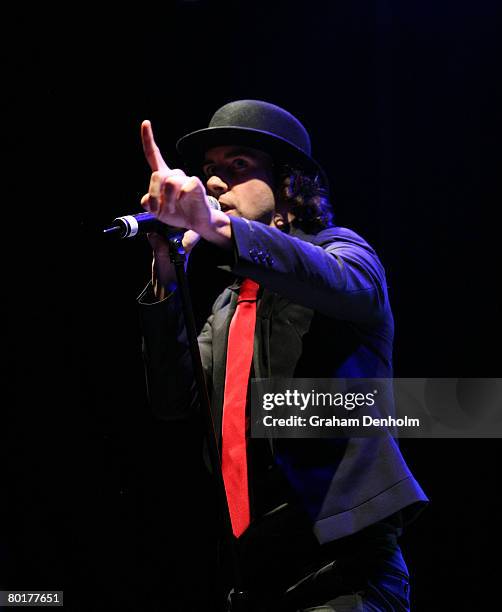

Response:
(4, 0), (501, 610)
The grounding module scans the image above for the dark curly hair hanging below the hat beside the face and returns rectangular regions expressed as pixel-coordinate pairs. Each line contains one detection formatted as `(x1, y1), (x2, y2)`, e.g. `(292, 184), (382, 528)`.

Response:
(276, 164), (335, 233)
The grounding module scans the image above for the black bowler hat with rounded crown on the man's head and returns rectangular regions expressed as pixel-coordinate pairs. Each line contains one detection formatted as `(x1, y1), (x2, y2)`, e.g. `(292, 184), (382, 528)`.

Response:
(176, 100), (328, 187)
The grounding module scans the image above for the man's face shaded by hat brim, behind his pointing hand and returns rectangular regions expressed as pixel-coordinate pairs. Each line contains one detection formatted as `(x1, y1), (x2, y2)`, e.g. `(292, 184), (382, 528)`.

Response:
(203, 146), (275, 225)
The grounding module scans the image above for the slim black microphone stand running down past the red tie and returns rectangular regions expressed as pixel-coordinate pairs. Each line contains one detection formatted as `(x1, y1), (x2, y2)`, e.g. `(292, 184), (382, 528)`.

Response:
(168, 233), (248, 612)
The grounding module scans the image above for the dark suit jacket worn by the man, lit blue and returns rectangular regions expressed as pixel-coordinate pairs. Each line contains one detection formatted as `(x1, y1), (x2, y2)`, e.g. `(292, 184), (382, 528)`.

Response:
(139, 218), (427, 543)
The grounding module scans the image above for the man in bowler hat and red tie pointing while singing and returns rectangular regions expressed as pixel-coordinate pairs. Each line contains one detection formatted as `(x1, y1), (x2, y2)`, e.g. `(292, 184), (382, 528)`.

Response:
(139, 100), (427, 610)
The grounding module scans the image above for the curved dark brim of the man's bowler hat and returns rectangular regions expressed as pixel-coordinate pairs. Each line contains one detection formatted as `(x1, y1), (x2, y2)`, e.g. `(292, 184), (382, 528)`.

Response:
(176, 126), (328, 187)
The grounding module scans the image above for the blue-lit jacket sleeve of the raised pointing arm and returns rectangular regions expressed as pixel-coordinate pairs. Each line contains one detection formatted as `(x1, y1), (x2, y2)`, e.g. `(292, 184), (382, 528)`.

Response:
(231, 218), (389, 325)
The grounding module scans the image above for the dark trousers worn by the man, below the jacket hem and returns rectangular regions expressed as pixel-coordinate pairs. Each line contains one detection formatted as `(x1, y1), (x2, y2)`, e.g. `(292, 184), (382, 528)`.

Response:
(223, 516), (410, 612)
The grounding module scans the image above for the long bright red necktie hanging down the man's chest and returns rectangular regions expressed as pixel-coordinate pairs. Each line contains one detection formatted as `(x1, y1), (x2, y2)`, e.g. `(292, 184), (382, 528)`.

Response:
(221, 278), (259, 538)
